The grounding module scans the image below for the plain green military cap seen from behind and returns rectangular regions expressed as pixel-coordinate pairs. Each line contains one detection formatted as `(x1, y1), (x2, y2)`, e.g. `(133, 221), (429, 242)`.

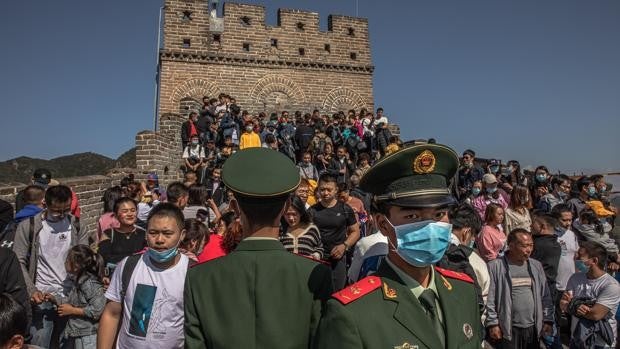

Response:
(222, 148), (301, 198)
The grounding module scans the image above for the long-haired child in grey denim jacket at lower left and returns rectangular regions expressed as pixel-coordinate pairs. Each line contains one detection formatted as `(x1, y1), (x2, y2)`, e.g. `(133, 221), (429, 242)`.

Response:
(46, 245), (106, 349)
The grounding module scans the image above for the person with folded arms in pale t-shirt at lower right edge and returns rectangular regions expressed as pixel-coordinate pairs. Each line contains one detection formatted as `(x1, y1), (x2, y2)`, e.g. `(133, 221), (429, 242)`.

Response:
(560, 241), (620, 348)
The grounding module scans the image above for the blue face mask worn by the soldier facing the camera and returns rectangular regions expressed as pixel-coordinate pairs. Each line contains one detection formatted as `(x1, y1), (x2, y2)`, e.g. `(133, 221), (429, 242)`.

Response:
(390, 220), (452, 268)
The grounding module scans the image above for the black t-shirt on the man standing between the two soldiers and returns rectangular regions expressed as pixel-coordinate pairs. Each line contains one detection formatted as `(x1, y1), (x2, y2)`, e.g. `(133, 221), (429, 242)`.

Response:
(310, 201), (357, 255)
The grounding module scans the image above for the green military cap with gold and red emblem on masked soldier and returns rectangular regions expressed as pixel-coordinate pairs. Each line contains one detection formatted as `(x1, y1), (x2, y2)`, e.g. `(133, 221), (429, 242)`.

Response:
(360, 144), (459, 207)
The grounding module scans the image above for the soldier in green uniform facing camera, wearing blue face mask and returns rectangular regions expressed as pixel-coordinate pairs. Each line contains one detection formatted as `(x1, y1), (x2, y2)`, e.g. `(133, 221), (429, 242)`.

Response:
(316, 144), (482, 349)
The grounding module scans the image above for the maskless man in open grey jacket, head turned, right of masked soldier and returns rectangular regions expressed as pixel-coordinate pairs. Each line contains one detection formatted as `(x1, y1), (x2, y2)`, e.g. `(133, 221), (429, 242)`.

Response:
(486, 229), (554, 349)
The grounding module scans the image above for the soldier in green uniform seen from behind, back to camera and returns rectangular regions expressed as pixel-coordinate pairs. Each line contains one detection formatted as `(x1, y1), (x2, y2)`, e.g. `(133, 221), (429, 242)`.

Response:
(184, 148), (333, 349)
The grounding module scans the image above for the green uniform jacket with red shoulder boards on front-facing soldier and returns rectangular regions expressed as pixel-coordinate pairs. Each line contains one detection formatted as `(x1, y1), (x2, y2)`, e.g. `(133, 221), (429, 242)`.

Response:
(316, 262), (482, 349)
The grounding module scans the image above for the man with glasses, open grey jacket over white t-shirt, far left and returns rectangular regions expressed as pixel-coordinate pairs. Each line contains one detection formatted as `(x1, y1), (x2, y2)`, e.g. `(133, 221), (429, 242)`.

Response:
(13, 185), (88, 348)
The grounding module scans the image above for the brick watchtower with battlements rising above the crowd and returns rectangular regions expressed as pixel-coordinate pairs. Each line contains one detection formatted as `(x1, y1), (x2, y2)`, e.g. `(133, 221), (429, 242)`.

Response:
(159, 0), (374, 117)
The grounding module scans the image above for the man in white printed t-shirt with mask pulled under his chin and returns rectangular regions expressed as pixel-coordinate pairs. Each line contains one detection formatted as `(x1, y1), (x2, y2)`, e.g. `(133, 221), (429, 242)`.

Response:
(97, 203), (189, 349)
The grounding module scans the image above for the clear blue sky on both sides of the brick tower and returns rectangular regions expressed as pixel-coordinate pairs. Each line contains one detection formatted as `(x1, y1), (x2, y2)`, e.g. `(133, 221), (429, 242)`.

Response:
(0, 0), (620, 172)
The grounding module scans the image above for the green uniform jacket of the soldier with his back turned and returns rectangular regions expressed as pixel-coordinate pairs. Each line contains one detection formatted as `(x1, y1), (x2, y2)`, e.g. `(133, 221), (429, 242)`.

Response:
(184, 239), (333, 349)
